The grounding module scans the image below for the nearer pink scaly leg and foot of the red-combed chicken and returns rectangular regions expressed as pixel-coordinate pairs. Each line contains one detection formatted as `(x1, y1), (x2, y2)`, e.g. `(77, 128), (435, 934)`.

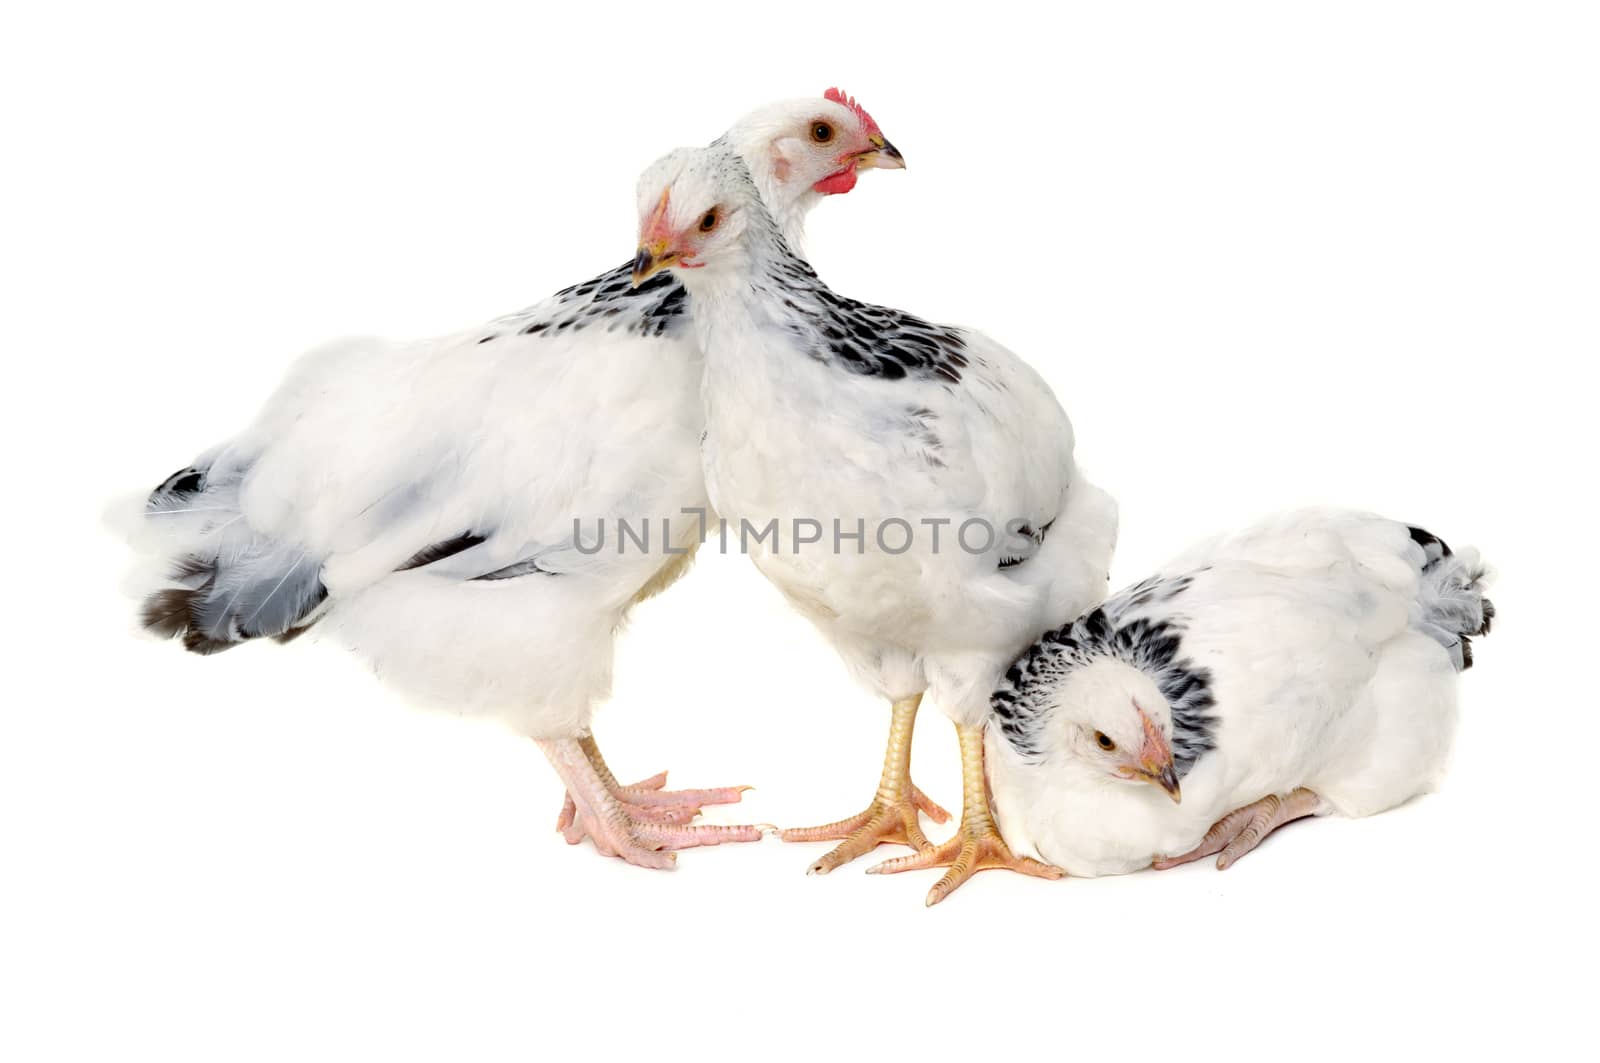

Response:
(539, 738), (762, 869)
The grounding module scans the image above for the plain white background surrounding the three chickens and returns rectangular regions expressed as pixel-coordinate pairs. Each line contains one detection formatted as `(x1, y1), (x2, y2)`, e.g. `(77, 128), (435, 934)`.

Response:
(0, 2), (1600, 1060)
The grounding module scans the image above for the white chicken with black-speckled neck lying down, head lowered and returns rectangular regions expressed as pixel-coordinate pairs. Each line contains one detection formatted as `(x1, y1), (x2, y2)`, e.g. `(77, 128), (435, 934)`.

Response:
(989, 511), (1494, 876)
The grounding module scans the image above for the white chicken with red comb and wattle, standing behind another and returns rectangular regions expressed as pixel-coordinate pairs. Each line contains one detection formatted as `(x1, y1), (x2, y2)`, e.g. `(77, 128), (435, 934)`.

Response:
(131, 90), (904, 868)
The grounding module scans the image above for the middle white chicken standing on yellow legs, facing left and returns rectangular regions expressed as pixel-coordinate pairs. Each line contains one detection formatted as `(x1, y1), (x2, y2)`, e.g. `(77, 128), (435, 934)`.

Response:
(634, 146), (1115, 905)
